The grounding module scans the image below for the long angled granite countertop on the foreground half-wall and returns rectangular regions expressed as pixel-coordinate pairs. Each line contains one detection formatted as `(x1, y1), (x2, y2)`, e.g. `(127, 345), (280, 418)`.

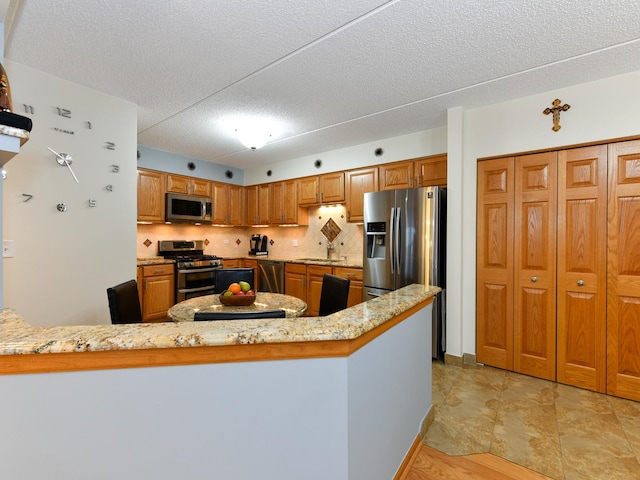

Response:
(0, 284), (440, 355)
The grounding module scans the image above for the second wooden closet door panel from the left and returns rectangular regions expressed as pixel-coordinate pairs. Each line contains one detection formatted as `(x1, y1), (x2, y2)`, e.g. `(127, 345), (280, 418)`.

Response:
(513, 152), (557, 380)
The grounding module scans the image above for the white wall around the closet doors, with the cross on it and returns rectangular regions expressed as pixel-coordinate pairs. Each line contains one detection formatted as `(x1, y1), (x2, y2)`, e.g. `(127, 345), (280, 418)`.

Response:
(447, 72), (640, 355)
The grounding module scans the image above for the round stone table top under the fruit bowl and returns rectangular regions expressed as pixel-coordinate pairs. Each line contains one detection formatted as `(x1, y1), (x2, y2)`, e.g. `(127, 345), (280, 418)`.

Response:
(168, 292), (307, 322)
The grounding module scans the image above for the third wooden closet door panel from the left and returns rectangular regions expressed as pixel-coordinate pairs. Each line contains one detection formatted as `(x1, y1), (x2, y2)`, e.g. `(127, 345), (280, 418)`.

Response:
(557, 145), (607, 392)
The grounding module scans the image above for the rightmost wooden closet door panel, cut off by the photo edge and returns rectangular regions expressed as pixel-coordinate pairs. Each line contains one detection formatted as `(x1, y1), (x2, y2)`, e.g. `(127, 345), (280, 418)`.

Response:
(607, 141), (640, 400)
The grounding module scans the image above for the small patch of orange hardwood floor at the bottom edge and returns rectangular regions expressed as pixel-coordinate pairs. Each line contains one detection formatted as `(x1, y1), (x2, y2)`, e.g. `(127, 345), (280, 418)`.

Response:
(401, 445), (549, 480)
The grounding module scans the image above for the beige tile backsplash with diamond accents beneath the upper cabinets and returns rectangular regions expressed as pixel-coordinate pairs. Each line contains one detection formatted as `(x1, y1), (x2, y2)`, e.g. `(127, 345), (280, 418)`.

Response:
(137, 205), (363, 262)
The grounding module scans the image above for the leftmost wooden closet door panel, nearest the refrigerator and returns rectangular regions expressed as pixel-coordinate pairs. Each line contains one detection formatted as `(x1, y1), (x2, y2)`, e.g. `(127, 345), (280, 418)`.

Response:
(476, 158), (514, 370)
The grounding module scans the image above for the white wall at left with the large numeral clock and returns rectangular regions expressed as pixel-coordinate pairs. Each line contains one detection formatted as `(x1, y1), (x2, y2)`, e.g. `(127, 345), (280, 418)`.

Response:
(2, 62), (136, 326)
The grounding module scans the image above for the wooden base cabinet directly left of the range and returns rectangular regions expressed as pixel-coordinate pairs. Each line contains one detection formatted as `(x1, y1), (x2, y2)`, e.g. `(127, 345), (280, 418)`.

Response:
(141, 263), (175, 322)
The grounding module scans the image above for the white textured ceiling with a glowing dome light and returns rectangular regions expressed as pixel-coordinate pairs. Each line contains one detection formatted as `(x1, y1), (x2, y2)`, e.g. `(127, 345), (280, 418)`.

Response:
(5, 0), (640, 168)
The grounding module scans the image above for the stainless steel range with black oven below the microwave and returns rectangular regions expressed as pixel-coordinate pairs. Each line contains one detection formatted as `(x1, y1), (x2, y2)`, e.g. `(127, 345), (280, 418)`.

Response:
(158, 240), (222, 302)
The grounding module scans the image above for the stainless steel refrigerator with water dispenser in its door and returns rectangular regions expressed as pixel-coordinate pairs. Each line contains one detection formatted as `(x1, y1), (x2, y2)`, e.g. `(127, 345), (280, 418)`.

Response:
(363, 187), (447, 358)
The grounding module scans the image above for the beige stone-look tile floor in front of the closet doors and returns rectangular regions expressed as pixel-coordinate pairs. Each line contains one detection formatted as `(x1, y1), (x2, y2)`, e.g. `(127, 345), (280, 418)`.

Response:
(424, 362), (640, 480)
